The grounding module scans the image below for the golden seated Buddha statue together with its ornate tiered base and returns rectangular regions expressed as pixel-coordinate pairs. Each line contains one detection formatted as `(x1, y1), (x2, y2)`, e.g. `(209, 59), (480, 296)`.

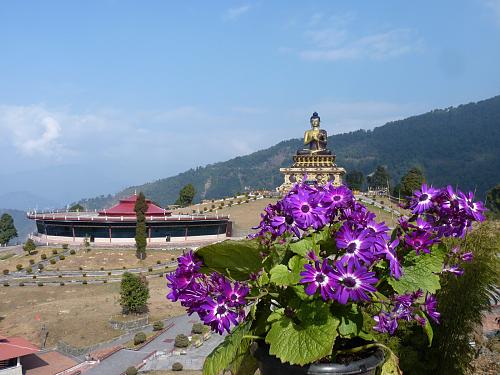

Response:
(278, 112), (346, 194)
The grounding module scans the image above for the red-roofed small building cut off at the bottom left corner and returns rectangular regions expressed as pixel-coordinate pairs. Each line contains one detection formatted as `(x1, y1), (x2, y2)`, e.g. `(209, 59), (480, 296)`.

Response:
(0, 335), (39, 375)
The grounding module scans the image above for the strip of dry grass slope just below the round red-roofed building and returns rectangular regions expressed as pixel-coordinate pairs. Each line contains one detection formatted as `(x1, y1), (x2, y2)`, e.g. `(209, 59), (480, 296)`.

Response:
(45, 248), (180, 271)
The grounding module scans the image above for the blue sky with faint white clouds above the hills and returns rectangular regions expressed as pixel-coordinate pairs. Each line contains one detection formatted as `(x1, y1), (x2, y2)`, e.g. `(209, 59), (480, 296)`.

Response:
(0, 0), (500, 204)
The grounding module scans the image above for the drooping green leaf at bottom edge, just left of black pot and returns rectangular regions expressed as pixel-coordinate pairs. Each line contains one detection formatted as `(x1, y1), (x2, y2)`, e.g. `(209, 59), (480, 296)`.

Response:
(203, 320), (252, 375)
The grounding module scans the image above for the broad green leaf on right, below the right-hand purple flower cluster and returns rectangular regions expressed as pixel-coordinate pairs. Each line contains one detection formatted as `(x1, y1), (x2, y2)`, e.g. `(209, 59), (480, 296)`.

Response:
(388, 246), (445, 294)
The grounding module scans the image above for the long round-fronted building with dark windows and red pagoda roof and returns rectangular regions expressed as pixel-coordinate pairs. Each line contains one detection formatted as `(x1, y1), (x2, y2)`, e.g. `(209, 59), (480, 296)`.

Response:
(27, 194), (232, 244)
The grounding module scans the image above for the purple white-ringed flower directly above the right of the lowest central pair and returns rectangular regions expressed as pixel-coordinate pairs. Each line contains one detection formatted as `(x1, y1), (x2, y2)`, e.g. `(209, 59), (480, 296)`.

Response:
(336, 224), (373, 266)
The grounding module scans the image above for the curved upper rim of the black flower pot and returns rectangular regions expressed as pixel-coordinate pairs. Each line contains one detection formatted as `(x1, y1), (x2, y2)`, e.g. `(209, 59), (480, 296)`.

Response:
(254, 343), (385, 375)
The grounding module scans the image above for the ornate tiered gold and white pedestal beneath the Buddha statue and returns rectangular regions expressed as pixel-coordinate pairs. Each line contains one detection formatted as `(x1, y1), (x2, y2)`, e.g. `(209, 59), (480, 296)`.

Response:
(277, 154), (346, 194)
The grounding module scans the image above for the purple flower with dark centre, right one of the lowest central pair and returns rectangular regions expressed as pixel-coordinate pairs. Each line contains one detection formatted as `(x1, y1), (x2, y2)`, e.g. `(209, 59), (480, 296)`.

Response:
(332, 262), (378, 305)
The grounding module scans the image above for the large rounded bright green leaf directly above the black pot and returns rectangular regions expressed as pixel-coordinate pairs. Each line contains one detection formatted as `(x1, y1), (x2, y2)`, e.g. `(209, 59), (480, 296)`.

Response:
(266, 301), (339, 365)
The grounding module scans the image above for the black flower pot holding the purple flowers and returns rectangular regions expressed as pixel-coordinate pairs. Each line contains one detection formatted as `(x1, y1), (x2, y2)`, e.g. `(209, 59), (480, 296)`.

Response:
(254, 345), (384, 375)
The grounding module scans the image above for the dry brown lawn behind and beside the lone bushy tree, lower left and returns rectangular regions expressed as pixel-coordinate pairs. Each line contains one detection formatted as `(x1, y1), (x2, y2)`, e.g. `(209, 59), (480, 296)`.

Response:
(0, 277), (184, 347)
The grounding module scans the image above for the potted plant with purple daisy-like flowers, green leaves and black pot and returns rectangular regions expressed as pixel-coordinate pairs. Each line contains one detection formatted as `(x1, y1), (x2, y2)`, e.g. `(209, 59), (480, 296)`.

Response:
(167, 184), (485, 375)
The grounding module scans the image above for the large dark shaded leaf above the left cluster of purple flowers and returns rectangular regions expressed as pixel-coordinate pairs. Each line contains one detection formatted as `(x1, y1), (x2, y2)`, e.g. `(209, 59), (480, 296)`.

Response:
(196, 240), (262, 280)
